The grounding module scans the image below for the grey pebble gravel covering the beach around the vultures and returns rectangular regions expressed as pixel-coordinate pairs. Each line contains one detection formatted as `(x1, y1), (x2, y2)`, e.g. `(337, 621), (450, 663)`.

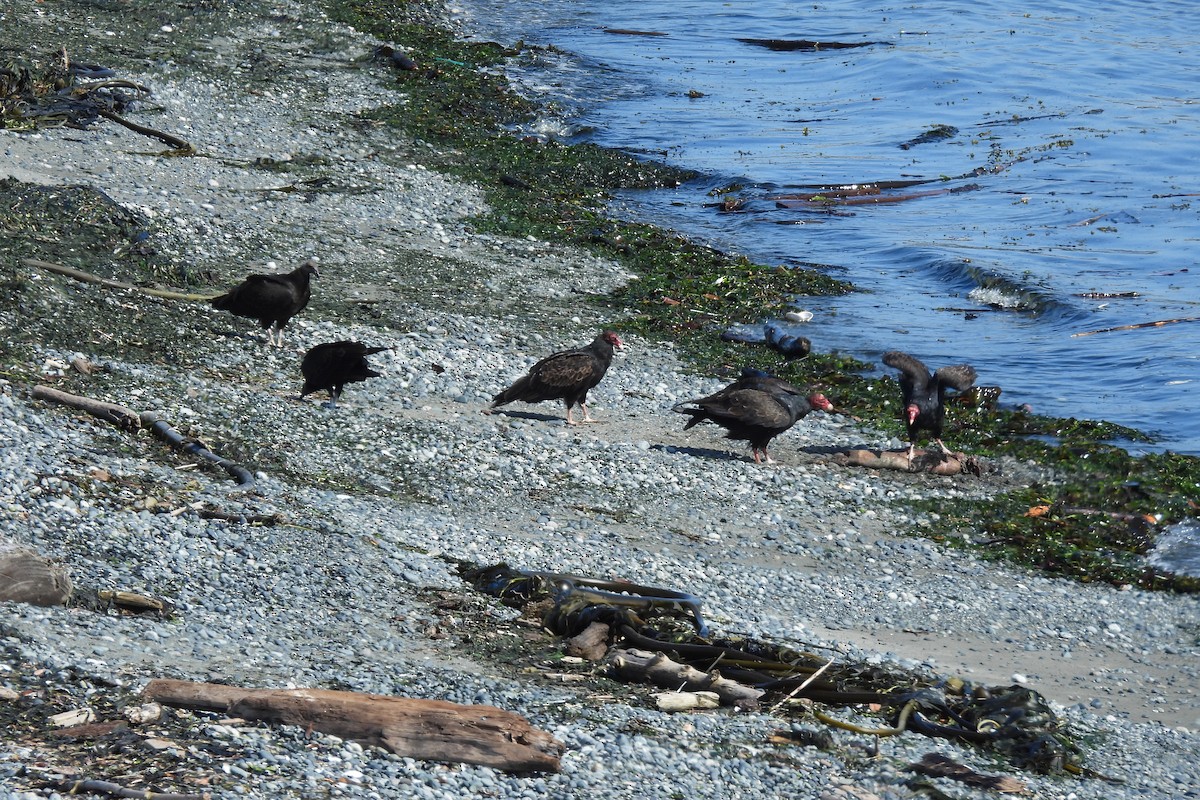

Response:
(0, 0), (1200, 800)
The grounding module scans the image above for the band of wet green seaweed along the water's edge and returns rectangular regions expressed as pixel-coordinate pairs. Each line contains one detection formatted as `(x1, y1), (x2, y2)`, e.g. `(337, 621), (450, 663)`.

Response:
(321, 0), (1200, 591)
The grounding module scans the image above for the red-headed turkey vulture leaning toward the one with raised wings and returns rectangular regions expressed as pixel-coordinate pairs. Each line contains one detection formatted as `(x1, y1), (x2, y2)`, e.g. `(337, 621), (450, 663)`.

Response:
(671, 369), (833, 463)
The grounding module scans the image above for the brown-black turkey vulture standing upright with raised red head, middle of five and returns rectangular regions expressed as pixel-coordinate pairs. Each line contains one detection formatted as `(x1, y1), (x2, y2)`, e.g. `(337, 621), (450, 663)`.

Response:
(485, 331), (624, 425)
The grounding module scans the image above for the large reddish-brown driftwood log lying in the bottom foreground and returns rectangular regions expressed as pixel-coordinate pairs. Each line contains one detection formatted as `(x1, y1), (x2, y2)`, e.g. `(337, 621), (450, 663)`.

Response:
(143, 680), (563, 772)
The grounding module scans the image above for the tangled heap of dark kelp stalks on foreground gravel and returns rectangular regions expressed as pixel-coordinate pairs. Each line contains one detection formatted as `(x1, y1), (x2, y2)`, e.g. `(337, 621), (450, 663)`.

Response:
(460, 563), (1085, 775)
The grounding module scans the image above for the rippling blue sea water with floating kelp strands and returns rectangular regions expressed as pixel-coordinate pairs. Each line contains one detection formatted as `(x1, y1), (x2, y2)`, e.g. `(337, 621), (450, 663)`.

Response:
(453, 0), (1200, 455)
